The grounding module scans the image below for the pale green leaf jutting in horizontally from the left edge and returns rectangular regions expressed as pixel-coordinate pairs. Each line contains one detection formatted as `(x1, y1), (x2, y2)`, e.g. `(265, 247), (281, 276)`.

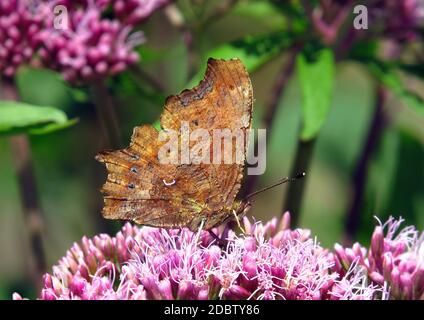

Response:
(0, 101), (77, 135)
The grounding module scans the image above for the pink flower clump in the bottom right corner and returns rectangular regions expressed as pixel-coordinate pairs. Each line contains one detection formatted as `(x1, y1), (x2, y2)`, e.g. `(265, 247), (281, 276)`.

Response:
(334, 218), (424, 300)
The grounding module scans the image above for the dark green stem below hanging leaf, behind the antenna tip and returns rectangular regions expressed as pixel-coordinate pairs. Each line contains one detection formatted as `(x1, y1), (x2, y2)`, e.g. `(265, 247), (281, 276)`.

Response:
(283, 138), (316, 227)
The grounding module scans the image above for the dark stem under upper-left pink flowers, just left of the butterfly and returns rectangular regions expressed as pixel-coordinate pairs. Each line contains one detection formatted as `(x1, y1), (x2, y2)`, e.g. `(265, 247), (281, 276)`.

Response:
(91, 81), (121, 149)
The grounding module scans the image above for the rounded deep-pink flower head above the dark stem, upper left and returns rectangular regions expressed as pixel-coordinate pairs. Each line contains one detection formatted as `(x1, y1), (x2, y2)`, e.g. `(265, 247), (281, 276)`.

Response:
(39, 0), (143, 82)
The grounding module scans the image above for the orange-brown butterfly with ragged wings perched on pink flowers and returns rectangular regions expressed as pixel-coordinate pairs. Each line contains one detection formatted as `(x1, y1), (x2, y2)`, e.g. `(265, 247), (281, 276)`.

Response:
(96, 59), (253, 231)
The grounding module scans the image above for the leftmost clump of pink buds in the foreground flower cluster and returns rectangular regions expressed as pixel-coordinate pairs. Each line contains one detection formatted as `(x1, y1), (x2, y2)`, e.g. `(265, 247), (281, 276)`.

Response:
(36, 224), (140, 300)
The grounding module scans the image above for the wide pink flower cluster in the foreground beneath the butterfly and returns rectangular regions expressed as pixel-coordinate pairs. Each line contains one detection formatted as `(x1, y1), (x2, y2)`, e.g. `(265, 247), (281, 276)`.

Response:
(14, 213), (424, 300)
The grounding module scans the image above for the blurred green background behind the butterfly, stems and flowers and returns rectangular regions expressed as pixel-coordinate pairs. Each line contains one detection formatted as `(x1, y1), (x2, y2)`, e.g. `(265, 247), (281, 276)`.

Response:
(0, 2), (424, 299)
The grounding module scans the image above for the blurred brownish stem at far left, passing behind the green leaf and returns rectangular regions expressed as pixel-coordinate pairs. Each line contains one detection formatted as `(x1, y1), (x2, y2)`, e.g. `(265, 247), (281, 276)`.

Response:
(2, 80), (46, 289)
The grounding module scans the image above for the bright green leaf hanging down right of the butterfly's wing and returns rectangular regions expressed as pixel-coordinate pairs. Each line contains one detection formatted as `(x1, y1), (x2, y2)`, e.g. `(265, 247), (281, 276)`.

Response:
(297, 49), (335, 141)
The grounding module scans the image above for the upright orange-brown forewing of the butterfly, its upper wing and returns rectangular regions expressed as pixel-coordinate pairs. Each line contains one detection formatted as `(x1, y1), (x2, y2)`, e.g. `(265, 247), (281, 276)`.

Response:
(161, 59), (253, 210)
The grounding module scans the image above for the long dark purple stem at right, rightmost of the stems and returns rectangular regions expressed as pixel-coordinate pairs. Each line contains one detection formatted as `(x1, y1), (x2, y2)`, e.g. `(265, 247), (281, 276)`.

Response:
(345, 84), (386, 241)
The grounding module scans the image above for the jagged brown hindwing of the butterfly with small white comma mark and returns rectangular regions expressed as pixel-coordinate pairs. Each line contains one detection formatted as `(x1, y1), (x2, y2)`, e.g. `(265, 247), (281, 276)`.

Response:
(96, 126), (211, 227)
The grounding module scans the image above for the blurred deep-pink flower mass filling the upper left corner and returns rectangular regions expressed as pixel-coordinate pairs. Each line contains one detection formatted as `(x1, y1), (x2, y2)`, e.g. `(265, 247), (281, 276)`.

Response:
(0, 0), (169, 83)
